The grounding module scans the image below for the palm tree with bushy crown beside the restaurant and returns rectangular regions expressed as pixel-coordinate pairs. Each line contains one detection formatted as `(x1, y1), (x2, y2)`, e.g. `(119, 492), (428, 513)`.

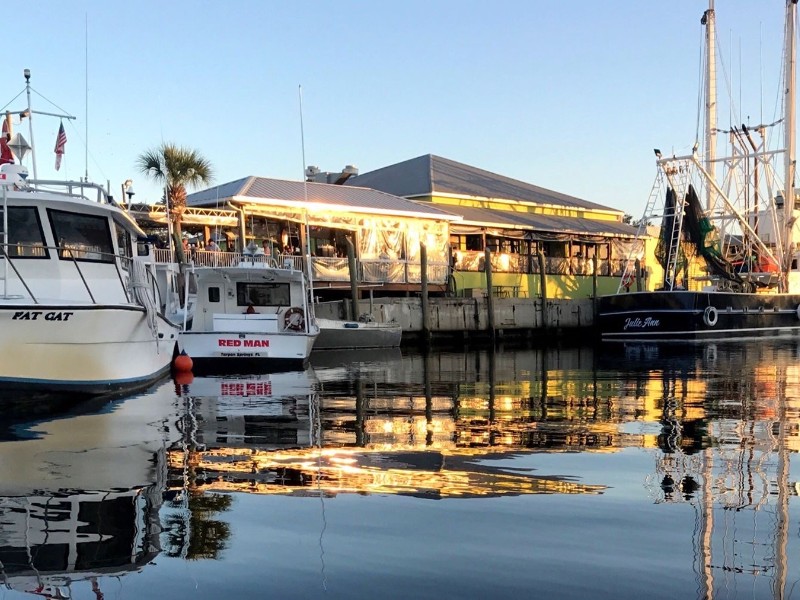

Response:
(136, 142), (212, 262)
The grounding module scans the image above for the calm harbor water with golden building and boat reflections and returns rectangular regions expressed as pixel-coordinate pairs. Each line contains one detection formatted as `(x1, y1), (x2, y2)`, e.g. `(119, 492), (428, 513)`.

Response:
(0, 343), (800, 600)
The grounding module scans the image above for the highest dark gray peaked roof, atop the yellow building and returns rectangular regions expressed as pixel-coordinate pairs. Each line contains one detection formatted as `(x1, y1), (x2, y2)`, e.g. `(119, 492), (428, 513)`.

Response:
(345, 154), (622, 215)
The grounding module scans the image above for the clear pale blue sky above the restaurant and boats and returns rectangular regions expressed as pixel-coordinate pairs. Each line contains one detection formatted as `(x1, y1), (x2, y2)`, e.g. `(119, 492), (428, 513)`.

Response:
(0, 0), (784, 218)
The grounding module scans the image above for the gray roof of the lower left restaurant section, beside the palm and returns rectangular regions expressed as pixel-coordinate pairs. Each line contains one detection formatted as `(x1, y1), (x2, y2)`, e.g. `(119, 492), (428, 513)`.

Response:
(186, 176), (457, 220)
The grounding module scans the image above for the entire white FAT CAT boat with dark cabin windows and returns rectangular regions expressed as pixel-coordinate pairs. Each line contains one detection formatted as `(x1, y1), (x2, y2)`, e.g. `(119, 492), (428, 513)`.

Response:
(0, 72), (179, 394)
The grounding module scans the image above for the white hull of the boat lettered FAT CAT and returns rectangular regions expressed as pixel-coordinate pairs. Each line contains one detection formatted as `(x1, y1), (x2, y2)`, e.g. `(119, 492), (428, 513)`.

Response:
(0, 304), (178, 394)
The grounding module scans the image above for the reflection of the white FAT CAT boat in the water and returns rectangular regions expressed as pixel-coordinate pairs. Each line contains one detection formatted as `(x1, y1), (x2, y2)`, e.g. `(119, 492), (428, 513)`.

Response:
(0, 382), (179, 598)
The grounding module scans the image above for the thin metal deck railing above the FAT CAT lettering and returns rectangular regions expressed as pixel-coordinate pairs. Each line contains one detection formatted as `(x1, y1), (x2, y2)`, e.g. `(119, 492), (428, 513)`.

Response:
(0, 244), (153, 304)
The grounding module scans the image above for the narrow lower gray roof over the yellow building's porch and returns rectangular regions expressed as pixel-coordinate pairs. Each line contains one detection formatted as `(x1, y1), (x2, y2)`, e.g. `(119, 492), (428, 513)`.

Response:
(438, 206), (637, 237)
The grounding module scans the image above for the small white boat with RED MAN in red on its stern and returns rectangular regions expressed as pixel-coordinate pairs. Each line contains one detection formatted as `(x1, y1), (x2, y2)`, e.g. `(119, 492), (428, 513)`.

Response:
(180, 258), (319, 374)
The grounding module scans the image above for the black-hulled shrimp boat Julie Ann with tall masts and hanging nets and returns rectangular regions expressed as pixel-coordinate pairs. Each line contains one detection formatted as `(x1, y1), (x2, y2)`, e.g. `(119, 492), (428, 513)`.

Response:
(597, 0), (800, 341)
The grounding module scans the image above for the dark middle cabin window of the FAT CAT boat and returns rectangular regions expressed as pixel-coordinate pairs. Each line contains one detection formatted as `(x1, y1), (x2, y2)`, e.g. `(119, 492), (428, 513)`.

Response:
(47, 209), (115, 263)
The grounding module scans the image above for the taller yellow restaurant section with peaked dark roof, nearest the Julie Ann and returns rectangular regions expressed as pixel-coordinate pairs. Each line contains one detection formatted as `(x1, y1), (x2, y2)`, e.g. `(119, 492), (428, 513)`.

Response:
(345, 154), (653, 298)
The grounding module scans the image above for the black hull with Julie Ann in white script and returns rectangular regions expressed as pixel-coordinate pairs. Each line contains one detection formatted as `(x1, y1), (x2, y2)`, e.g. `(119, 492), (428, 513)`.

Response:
(597, 290), (800, 342)
